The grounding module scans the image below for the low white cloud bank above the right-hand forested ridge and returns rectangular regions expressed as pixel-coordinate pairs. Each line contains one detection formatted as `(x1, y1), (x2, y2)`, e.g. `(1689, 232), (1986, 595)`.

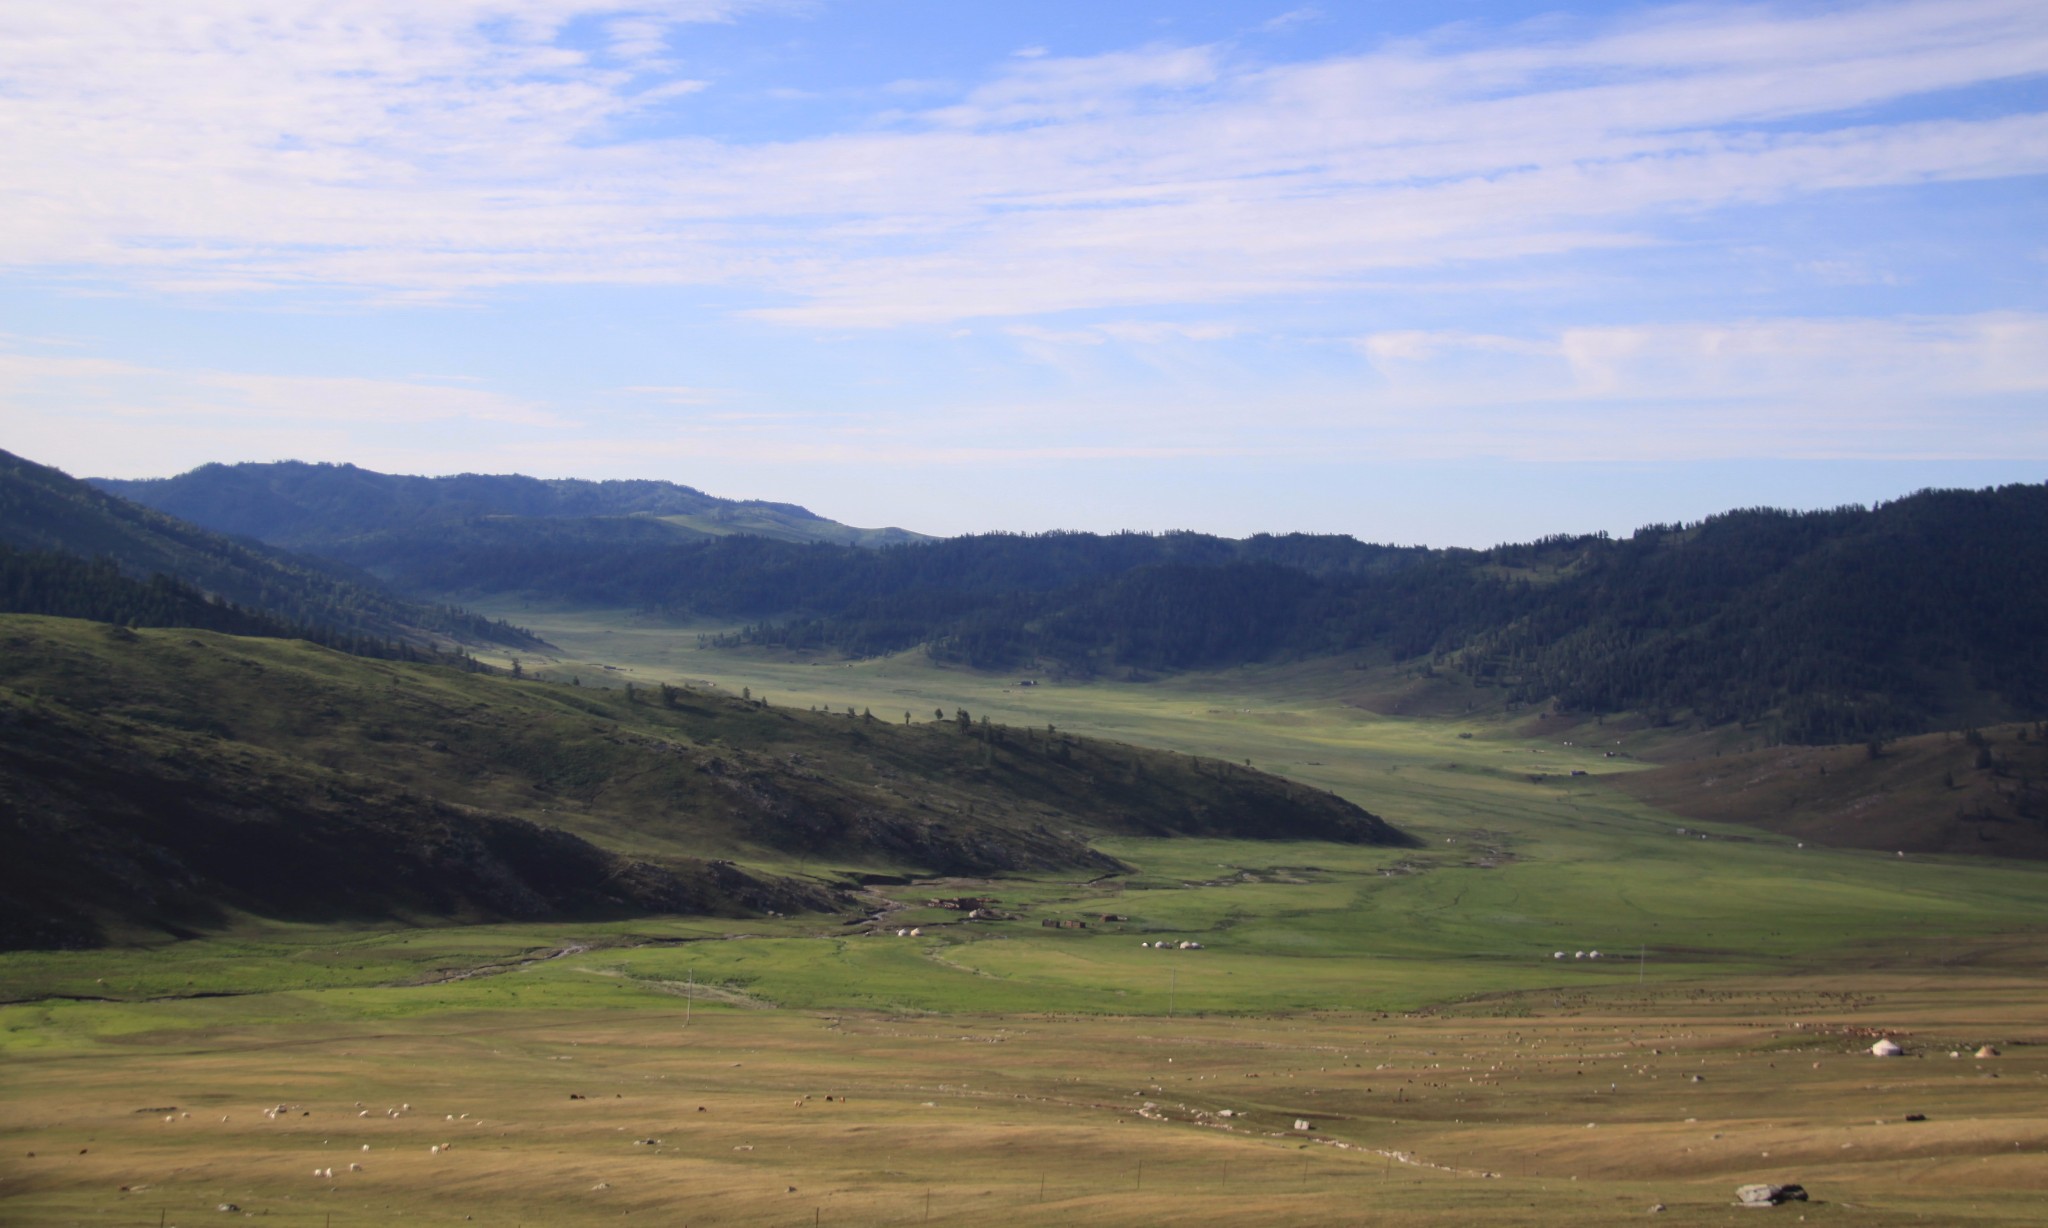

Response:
(1356, 313), (2048, 461)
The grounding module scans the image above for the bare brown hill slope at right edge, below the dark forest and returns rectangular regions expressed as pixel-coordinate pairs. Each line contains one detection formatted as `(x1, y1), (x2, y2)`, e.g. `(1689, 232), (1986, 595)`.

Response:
(1608, 725), (2048, 858)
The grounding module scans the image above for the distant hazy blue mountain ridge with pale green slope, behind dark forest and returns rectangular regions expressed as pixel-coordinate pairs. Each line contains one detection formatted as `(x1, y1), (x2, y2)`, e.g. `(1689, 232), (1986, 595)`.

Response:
(90, 461), (930, 551)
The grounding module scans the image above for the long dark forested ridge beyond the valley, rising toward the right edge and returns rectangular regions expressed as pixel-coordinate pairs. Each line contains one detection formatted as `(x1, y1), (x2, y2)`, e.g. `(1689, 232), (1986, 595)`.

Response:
(68, 450), (2048, 743)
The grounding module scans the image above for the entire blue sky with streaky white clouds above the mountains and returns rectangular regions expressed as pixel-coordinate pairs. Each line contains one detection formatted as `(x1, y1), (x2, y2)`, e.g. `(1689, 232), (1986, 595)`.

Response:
(0, 0), (2048, 544)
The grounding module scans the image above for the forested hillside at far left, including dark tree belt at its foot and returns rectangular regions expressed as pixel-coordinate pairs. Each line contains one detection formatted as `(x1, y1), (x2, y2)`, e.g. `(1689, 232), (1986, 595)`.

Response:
(0, 452), (539, 647)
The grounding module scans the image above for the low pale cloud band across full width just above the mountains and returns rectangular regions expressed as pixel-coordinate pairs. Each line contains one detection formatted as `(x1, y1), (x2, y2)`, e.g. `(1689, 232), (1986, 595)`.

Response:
(0, 313), (2048, 493)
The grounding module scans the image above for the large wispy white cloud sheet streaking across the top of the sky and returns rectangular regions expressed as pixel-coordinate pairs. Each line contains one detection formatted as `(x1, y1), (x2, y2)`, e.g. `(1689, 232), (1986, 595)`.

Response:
(0, 0), (2048, 327)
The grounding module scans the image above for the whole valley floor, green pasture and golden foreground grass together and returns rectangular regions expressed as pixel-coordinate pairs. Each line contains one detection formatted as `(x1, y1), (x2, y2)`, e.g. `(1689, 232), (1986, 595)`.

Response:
(12, 610), (2048, 1228)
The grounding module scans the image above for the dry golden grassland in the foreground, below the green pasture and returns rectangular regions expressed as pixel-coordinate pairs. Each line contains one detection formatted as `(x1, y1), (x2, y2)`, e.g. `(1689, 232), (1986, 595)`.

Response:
(0, 966), (2048, 1226)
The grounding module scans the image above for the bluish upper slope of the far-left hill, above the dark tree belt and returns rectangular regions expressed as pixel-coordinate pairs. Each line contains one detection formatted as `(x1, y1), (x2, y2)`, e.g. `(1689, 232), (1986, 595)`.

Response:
(0, 452), (539, 647)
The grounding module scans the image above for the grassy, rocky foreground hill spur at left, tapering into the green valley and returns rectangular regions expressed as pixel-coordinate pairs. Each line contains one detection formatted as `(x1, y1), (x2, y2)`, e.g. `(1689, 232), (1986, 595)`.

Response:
(0, 616), (1407, 944)
